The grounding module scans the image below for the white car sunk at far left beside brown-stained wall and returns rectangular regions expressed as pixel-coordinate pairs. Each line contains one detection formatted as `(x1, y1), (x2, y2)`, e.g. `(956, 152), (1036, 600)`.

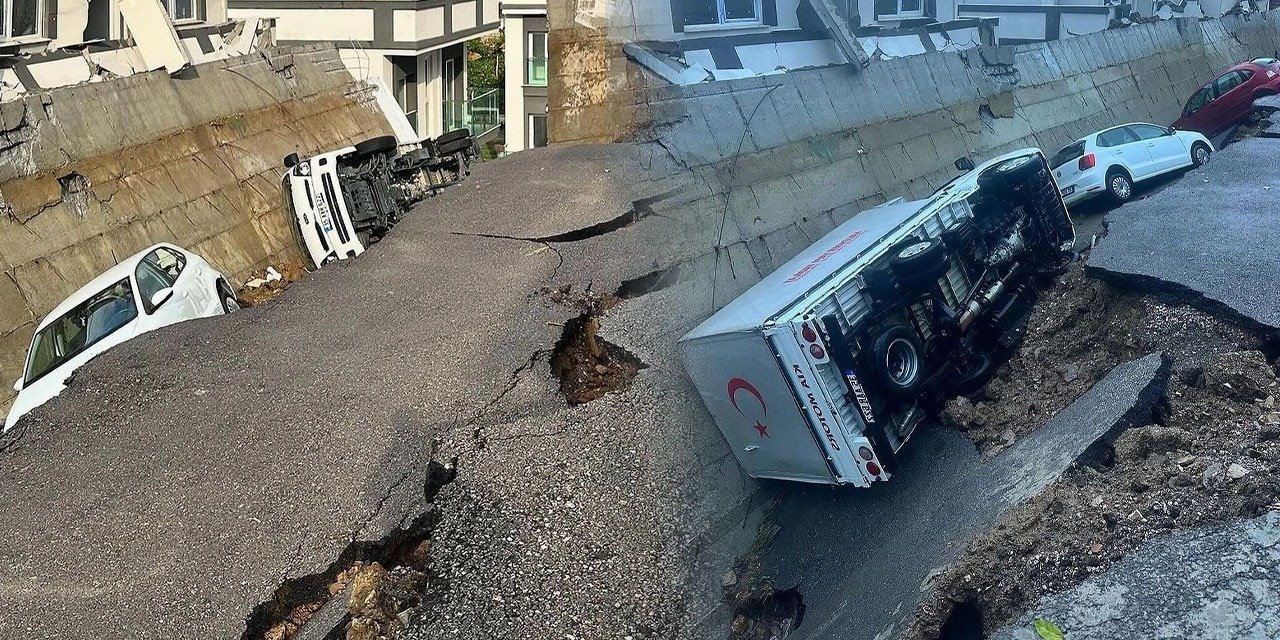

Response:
(4, 243), (239, 431)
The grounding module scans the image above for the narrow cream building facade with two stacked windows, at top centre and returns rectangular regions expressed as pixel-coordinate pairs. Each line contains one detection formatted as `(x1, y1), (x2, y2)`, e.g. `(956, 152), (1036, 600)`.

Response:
(502, 0), (550, 154)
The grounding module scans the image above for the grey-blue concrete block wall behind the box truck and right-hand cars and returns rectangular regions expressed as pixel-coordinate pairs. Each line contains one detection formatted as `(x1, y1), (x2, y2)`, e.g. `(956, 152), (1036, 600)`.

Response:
(640, 12), (1280, 307)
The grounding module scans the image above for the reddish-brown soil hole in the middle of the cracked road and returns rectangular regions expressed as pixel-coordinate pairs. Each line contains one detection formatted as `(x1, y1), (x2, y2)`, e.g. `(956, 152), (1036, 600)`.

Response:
(550, 312), (645, 404)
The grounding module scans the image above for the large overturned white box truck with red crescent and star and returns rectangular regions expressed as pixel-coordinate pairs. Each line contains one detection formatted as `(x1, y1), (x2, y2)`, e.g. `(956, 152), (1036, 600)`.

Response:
(680, 148), (1075, 486)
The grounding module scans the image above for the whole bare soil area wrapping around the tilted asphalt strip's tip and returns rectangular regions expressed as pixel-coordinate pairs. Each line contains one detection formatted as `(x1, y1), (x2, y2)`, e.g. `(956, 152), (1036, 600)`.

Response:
(904, 269), (1280, 640)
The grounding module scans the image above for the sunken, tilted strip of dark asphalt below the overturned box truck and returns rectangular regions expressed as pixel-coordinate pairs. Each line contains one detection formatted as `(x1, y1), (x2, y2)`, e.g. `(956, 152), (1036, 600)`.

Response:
(765, 355), (1167, 639)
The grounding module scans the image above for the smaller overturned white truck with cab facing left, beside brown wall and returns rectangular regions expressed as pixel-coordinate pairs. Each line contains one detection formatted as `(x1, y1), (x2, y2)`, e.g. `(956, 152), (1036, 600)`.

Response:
(283, 129), (476, 269)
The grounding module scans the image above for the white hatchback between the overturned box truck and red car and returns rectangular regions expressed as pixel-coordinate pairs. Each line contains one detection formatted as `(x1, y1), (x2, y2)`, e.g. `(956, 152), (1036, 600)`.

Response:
(1050, 123), (1213, 206)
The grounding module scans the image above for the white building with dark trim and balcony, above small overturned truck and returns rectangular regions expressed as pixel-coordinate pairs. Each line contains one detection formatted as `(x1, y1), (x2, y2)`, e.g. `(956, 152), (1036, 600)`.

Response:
(230, 0), (503, 137)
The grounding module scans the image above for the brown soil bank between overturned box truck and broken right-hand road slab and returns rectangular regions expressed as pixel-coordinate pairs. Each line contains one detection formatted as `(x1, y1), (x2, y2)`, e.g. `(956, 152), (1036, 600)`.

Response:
(941, 264), (1261, 456)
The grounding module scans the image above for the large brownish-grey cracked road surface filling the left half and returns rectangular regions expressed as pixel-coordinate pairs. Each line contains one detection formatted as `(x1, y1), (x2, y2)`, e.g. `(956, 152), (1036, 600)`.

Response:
(0, 146), (731, 639)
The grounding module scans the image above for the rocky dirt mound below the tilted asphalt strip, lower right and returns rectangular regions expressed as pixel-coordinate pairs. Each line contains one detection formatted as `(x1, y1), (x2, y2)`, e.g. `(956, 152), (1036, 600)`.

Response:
(904, 352), (1280, 640)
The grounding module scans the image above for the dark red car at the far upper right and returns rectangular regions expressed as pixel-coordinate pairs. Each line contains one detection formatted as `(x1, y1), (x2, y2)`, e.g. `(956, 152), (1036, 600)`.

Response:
(1174, 58), (1280, 137)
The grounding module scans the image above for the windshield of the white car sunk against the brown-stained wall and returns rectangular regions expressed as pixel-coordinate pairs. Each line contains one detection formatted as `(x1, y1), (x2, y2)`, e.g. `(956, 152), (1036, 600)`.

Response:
(26, 278), (138, 384)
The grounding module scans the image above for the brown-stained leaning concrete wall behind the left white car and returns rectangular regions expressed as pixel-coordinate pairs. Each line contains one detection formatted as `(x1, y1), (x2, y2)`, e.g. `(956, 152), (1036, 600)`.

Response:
(0, 46), (389, 407)
